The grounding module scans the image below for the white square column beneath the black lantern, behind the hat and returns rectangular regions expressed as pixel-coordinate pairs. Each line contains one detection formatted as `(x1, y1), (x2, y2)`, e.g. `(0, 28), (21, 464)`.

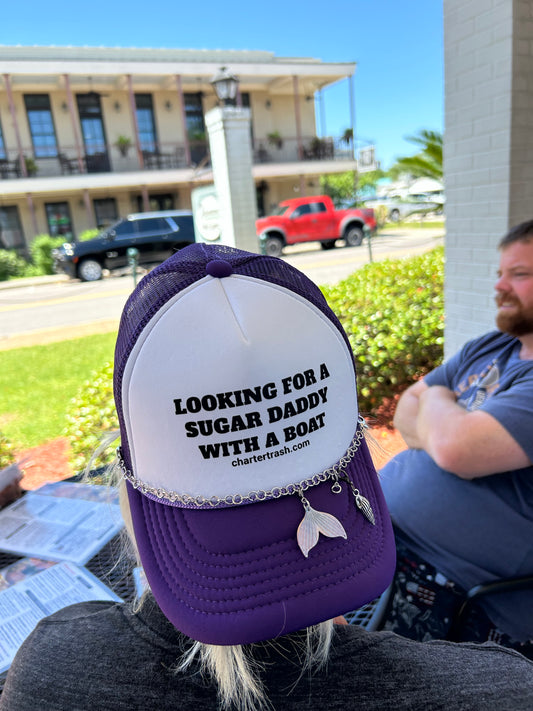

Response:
(205, 106), (260, 253)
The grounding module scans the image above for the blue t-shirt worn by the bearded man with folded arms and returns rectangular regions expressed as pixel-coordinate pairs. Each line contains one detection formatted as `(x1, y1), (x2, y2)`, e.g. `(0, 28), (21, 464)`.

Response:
(381, 331), (533, 640)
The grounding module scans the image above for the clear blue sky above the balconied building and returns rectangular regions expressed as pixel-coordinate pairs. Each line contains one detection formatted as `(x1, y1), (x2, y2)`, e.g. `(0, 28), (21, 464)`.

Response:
(0, 0), (444, 169)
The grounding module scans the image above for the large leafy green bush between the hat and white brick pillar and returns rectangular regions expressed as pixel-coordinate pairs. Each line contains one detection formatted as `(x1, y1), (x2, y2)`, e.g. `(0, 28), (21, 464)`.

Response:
(322, 247), (444, 416)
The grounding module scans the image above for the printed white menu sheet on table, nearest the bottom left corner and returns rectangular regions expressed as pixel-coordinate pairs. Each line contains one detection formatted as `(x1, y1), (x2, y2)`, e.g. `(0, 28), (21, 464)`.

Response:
(0, 562), (121, 673)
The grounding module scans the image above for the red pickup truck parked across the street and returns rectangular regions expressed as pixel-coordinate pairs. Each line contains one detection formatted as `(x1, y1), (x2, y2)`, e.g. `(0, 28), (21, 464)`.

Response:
(255, 195), (377, 257)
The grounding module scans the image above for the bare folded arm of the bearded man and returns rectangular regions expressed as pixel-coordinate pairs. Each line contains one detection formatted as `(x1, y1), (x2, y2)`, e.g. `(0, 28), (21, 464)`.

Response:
(418, 383), (531, 479)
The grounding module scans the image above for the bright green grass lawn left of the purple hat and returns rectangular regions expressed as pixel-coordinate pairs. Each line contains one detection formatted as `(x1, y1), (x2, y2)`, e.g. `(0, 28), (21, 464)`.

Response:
(0, 333), (116, 449)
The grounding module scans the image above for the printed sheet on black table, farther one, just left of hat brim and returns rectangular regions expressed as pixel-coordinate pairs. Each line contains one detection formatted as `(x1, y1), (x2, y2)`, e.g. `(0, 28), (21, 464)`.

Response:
(0, 484), (124, 565)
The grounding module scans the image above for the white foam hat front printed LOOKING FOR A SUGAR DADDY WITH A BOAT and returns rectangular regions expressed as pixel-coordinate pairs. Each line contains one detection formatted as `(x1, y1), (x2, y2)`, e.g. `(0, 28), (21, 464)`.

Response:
(122, 274), (358, 506)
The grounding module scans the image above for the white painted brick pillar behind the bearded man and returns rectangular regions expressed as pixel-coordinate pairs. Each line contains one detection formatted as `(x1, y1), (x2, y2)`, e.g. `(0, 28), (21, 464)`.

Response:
(444, 0), (533, 356)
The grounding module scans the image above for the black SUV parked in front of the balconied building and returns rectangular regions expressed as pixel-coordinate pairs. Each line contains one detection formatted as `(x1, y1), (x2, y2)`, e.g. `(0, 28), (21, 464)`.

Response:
(52, 210), (195, 281)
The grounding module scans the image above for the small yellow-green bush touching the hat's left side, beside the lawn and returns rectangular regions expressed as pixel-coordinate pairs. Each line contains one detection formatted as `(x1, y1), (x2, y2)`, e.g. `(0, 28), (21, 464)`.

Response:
(64, 363), (118, 472)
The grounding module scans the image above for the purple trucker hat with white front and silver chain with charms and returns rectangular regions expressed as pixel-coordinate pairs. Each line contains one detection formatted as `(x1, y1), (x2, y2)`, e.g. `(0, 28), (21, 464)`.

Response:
(114, 244), (395, 645)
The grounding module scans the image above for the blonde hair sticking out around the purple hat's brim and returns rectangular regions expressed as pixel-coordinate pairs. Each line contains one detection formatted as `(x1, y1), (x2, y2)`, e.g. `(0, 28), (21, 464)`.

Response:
(109, 463), (334, 711)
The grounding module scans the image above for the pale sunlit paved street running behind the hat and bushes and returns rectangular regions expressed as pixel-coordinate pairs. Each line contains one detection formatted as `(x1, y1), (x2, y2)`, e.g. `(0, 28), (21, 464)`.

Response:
(0, 228), (444, 350)
